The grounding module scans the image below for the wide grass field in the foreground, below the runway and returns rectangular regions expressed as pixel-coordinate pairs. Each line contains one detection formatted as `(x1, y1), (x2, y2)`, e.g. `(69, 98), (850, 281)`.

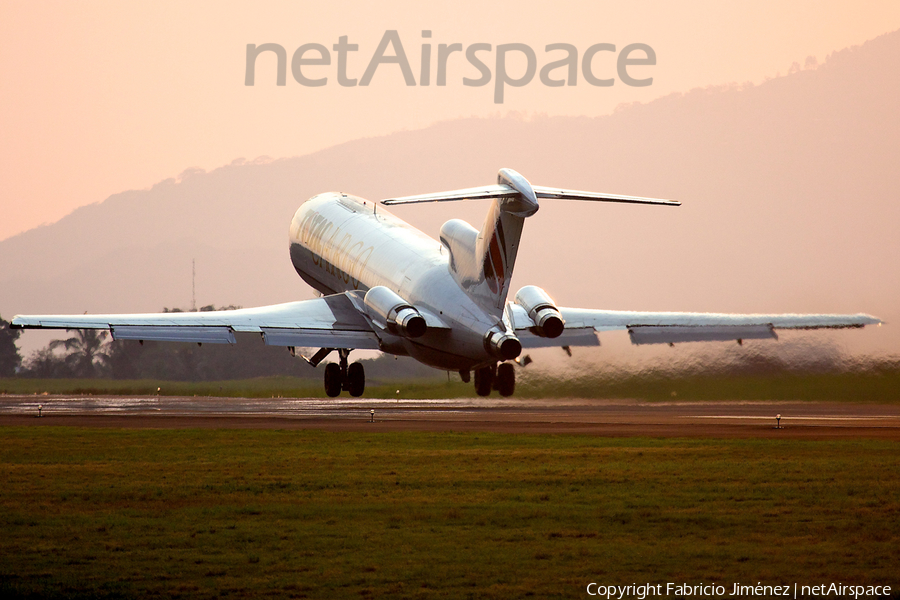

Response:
(0, 427), (900, 598)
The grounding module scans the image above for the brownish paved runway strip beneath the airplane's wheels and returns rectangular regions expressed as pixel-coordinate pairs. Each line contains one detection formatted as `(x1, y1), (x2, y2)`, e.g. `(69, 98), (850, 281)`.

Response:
(0, 395), (900, 440)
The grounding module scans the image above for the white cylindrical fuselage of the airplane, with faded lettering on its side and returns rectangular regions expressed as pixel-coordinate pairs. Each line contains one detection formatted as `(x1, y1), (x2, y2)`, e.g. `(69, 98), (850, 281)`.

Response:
(290, 192), (508, 370)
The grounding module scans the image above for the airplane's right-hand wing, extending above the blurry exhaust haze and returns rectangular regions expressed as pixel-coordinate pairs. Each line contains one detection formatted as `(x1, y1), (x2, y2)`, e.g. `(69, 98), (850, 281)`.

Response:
(510, 305), (882, 348)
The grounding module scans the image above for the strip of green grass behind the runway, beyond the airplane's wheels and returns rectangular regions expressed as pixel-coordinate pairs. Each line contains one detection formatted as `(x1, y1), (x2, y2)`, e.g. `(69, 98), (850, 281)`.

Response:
(0, 369), (900, 404)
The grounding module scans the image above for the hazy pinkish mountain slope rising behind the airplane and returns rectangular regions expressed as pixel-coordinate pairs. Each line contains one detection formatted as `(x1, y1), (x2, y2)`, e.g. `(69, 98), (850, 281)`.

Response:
(0, 32), (900, 352)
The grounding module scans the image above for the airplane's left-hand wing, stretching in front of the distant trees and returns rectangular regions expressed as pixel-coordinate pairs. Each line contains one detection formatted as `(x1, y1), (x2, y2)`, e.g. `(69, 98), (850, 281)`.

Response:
(10, 293), (379, 350)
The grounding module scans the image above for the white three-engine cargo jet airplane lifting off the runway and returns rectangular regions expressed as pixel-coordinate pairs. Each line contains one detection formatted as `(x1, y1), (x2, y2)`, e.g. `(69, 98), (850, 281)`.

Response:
(11, 169), (881, 397)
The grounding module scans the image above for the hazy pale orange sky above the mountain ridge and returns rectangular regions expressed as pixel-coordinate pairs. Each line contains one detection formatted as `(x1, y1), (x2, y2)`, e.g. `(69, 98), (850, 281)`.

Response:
(0, 0), (900, 239)
